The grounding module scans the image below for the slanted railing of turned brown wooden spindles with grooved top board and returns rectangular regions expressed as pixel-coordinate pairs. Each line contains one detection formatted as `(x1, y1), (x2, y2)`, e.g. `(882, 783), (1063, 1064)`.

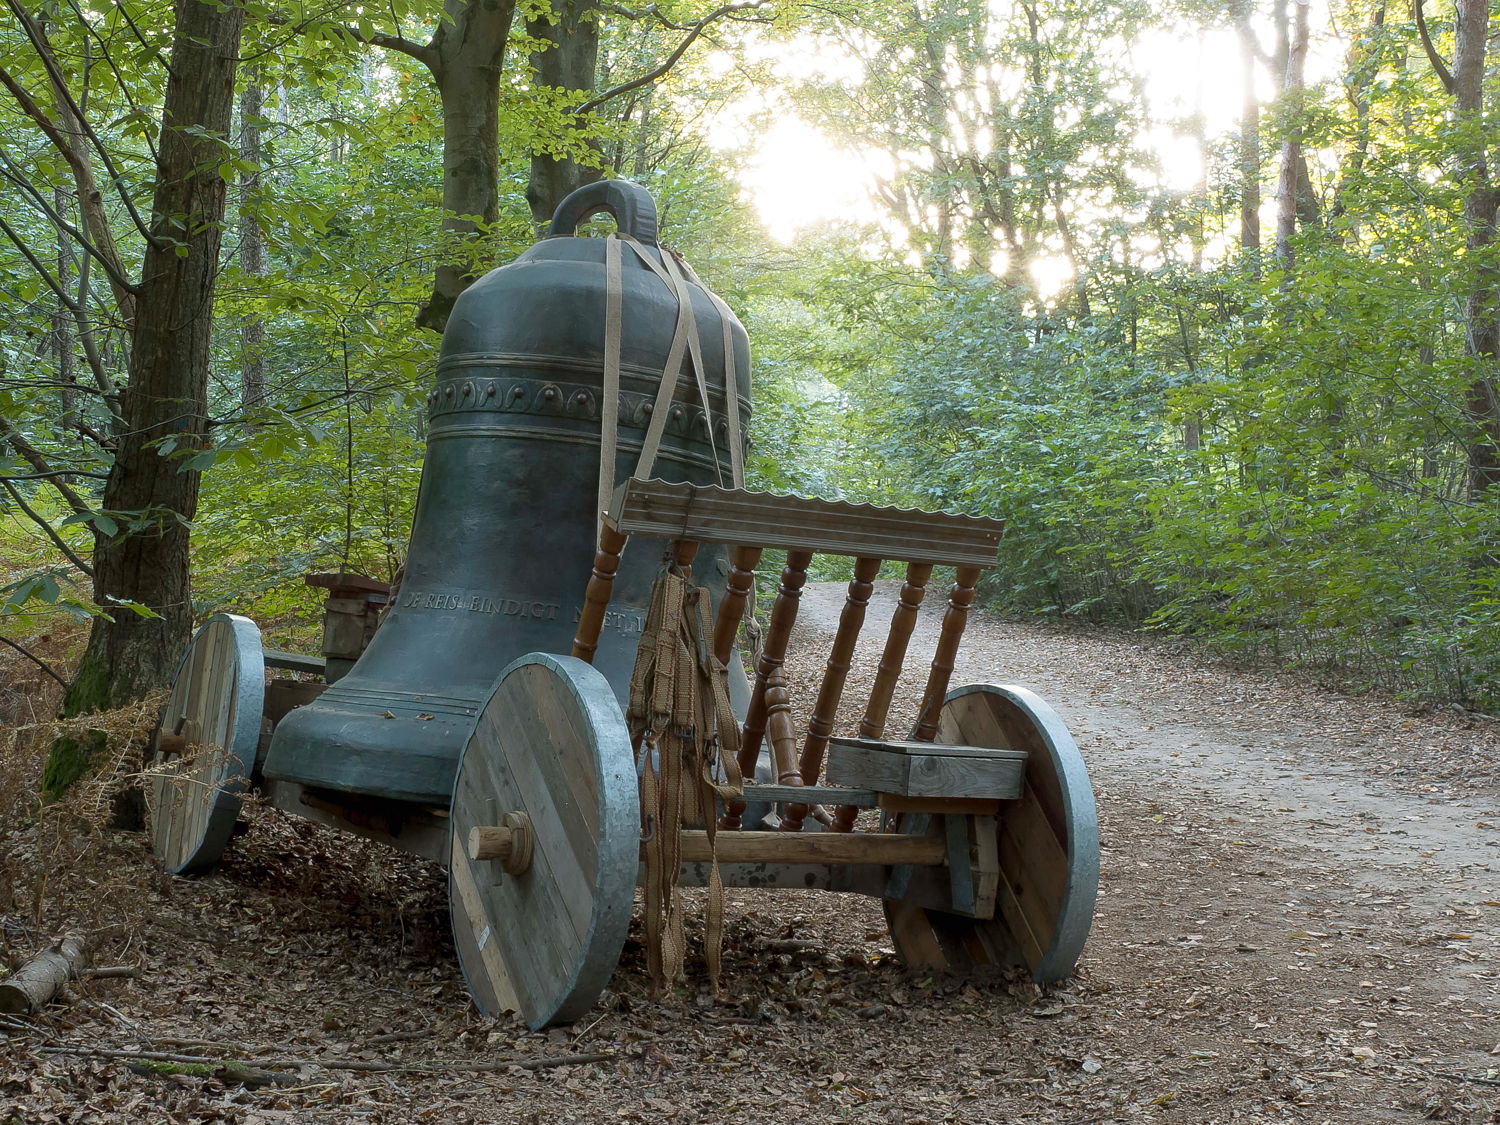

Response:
(573, 479), (1004, 861)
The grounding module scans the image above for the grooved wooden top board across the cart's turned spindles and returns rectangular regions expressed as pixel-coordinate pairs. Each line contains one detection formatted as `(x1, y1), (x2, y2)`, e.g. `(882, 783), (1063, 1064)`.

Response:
(606, 477), (1005, 567)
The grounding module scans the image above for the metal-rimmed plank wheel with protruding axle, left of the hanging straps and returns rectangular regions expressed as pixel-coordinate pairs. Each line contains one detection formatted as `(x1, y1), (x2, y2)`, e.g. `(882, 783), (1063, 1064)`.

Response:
(449, 653), (641, 1028)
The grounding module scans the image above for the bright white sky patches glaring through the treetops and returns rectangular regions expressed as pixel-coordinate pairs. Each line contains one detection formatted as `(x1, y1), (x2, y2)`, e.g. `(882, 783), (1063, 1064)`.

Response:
(708, 0), (1344, 296)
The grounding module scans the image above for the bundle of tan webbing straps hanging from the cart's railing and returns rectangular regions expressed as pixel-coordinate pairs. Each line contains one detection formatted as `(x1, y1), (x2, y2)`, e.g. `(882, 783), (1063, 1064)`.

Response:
(626, 566), (744, 995)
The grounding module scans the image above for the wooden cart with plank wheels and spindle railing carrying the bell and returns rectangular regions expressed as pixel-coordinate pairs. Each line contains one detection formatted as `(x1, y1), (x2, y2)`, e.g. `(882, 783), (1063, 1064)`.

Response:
(150, 479), (1098, 1028)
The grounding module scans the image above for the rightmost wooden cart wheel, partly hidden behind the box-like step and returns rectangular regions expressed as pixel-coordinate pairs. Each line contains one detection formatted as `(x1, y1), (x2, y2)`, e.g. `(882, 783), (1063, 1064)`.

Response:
(885, 684), (1100, 984)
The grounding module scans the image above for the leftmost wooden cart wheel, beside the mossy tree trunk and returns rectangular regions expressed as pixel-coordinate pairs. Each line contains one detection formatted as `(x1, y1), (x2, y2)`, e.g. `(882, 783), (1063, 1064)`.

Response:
(146, 614), (266, 875)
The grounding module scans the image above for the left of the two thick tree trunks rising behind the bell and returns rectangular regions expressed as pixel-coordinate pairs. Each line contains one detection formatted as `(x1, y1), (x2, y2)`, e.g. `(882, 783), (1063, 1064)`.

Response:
(417, 0), (516, 332)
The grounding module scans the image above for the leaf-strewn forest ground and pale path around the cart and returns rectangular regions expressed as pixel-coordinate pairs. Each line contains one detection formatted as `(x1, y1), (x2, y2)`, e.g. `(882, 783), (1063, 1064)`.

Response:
(0, 584), (1500, 1125)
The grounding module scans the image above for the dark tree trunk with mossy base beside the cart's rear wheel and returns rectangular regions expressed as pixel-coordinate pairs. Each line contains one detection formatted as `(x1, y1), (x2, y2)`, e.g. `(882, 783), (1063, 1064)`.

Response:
(44, 0), (245, 794)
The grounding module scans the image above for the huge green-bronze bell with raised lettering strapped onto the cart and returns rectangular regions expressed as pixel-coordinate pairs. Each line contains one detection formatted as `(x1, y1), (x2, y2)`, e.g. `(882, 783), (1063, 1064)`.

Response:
(263, 180), (750, 806)
